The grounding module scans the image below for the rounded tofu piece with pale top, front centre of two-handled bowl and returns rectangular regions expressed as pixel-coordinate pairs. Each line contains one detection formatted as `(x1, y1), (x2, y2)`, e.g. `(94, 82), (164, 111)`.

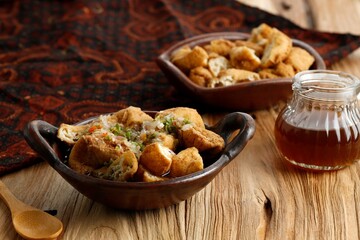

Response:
(139, 142), (175, 177)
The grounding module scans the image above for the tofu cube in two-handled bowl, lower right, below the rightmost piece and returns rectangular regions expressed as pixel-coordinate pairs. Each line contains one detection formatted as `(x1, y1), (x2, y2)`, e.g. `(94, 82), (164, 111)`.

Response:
(169, 147), (204, 177)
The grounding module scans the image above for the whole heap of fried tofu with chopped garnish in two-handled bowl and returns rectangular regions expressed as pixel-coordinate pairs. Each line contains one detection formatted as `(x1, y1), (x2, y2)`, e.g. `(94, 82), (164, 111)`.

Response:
(57, 107), (225, 182)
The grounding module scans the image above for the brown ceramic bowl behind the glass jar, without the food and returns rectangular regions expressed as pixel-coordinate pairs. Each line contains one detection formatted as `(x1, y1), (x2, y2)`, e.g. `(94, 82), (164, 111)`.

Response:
(157, 32), (326, 111)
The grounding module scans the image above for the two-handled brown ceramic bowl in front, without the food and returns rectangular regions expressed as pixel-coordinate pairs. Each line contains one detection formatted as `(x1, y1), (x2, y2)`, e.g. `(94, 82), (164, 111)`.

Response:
(24, 112), (255, 210)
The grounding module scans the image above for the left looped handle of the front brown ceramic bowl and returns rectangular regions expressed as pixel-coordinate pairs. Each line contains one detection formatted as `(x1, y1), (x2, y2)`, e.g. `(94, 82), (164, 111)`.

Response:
(24, 120), (60, 166)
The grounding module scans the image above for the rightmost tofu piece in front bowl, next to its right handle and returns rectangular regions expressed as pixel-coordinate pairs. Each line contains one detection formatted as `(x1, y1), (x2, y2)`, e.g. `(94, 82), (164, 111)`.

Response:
(179, 126), (225, 154)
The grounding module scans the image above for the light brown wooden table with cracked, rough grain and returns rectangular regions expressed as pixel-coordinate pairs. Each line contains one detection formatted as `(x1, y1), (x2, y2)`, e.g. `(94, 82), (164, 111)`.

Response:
(0, 0), (360, 240)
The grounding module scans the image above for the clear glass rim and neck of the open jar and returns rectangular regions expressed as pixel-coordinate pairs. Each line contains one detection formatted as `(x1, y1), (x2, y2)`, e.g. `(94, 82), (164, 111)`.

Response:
(292, 70), (360, 101)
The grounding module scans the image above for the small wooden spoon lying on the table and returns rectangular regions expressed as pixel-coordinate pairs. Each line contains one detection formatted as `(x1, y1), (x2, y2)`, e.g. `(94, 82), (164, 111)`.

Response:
(0, 180), (63, 239)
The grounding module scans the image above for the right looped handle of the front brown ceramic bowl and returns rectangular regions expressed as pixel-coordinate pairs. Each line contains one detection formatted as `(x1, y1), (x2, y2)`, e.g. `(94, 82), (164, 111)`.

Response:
(209, 112), (255, 162)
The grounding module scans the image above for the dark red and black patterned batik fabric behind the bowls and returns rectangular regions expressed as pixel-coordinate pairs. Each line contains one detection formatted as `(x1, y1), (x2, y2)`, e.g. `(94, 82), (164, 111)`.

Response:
(0, 0), (360, 175)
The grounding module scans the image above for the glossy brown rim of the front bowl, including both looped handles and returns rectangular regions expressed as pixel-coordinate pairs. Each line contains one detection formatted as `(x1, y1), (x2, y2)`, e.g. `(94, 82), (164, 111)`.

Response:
(24, 111), (255, 190)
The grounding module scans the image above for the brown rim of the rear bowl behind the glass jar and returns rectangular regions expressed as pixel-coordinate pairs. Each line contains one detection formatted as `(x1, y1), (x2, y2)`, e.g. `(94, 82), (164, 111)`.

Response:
(157, 32), (326, 94)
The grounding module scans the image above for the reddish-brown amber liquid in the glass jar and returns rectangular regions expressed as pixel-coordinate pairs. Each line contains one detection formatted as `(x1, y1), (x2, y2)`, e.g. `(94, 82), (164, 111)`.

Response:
(275, 112), (360, 170)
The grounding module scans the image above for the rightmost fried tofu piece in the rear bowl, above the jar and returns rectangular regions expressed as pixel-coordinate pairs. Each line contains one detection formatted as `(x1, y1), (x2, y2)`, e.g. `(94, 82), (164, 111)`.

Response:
(285, 47), (315, 72)
